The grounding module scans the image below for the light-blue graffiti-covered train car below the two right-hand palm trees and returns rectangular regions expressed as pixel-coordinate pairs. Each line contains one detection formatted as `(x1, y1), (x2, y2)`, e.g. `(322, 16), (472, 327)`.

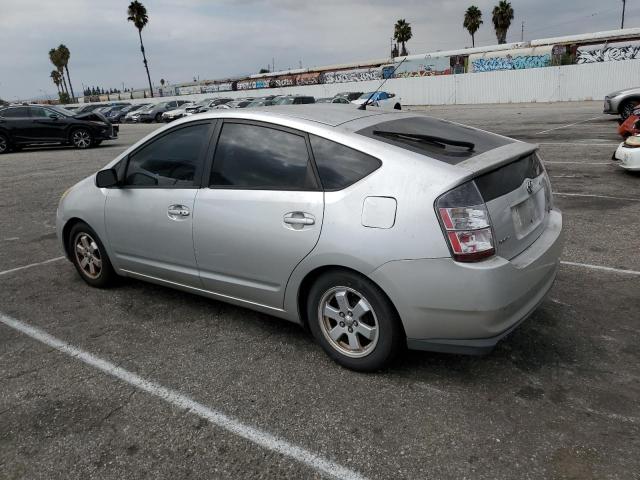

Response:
(469, 46), (553, 72)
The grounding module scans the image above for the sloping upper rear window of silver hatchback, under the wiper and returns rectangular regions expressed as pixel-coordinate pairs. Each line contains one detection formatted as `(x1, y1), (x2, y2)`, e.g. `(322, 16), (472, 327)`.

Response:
(357, 116), (514, 165)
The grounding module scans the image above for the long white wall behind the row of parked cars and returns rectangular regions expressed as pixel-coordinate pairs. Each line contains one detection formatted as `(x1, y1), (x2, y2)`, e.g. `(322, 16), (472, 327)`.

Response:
(91, 60), (640, 105)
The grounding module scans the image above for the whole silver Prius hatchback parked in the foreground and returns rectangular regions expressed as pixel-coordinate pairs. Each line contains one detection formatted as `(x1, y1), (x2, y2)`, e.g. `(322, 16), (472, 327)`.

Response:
(57, 104), (562, 371)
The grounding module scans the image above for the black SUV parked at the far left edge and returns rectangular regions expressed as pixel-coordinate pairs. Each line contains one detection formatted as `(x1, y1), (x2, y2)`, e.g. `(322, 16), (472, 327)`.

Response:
(0, 105), (118, 154)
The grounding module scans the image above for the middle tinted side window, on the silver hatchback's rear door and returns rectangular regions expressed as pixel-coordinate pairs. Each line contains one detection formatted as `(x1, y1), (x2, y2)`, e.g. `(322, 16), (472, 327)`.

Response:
(210, 123), (316, 190)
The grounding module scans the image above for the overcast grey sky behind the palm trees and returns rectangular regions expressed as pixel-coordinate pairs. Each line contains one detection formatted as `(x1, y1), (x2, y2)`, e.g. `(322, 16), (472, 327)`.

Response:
(0, 0), (640, 100)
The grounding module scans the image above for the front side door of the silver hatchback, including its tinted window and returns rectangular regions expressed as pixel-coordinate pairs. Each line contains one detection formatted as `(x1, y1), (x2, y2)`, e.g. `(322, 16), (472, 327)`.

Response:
(105, 121), (212, 287)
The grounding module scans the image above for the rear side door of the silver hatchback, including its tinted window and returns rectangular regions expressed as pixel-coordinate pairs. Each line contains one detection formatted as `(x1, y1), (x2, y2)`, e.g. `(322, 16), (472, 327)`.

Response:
(193, 121), (324, 308)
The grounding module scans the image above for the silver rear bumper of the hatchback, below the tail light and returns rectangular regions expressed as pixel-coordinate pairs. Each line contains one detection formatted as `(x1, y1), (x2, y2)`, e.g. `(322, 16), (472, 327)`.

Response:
(370, 210), (563, 354)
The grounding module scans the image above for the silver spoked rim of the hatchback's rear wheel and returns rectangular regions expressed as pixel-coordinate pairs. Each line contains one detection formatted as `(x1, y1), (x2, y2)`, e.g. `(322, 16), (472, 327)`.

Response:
(318, 287), (380, 358)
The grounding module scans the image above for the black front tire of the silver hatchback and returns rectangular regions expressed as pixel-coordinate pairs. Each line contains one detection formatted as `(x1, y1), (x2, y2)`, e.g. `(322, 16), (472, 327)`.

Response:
(67, 222), (117, 288)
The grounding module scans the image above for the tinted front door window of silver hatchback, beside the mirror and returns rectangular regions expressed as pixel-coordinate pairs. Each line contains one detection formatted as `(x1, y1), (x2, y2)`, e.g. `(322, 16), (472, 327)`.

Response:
(124, 123), (210, 188)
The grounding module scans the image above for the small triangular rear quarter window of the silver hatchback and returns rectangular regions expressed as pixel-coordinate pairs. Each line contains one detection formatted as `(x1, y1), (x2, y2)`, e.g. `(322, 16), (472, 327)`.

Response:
(309, 135), (382, 190)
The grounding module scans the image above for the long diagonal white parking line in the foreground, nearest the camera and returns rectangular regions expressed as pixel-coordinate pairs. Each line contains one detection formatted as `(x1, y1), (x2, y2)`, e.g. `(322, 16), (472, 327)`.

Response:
(0, 313), (365, 480)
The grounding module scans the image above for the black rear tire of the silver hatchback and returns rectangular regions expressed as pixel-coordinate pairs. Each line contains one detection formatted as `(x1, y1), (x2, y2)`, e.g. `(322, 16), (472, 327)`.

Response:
(307, 271), (404, 372)
